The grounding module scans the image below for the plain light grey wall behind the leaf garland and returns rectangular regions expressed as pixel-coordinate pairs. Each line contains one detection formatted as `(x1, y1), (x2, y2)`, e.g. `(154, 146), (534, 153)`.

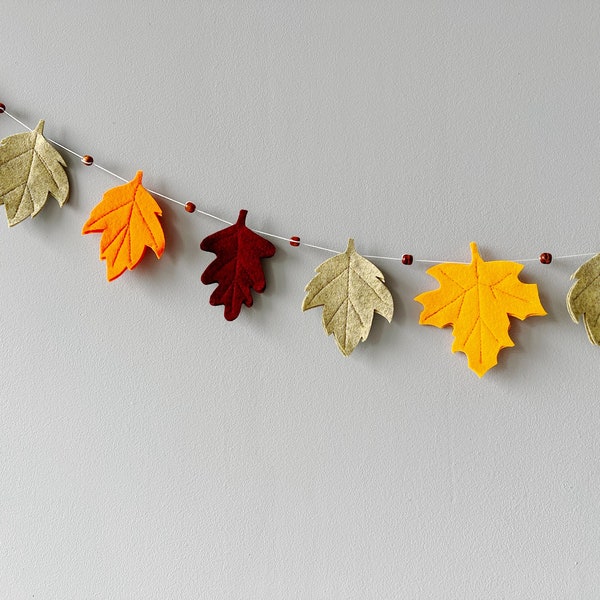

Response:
(0, 0), (600, 600)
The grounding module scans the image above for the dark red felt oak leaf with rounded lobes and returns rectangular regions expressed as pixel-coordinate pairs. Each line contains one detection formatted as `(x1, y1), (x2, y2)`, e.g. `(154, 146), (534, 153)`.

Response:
(200, 210), (275, 321)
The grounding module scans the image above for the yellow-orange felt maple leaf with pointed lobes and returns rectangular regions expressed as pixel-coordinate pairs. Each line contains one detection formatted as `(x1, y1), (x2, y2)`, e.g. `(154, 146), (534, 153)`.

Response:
(415, 243), (546, 377)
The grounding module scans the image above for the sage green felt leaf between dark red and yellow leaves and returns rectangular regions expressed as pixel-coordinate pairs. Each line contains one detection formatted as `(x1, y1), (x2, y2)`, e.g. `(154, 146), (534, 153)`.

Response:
(302, 239), (394, 356)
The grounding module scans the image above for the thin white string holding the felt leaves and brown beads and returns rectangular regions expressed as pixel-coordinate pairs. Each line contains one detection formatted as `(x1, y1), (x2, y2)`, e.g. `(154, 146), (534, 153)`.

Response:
(4, 109), (597, 265)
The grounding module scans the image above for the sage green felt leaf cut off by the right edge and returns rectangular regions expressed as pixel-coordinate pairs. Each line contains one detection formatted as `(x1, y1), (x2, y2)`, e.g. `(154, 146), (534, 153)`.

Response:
(567, 254), (600, 346)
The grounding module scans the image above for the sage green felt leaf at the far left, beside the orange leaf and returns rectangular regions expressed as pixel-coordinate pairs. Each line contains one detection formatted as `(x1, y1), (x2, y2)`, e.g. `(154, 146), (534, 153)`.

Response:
(0, 121), (69, 227)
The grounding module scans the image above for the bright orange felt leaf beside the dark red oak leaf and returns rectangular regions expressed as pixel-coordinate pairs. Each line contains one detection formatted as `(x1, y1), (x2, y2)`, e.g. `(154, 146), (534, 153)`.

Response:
(82, 171), (165, 281)
